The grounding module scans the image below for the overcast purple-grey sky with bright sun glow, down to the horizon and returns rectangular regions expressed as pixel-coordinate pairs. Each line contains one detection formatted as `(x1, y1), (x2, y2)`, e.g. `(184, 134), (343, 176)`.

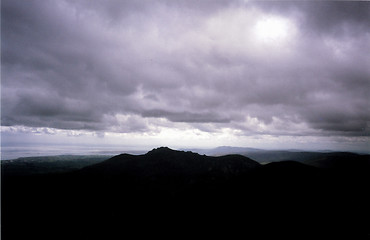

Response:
(1, 0), (370, 151)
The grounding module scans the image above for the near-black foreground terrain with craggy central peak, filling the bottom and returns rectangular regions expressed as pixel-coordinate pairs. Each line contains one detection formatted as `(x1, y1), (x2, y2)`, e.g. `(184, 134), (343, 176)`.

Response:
(1, 148), (370, 240)
